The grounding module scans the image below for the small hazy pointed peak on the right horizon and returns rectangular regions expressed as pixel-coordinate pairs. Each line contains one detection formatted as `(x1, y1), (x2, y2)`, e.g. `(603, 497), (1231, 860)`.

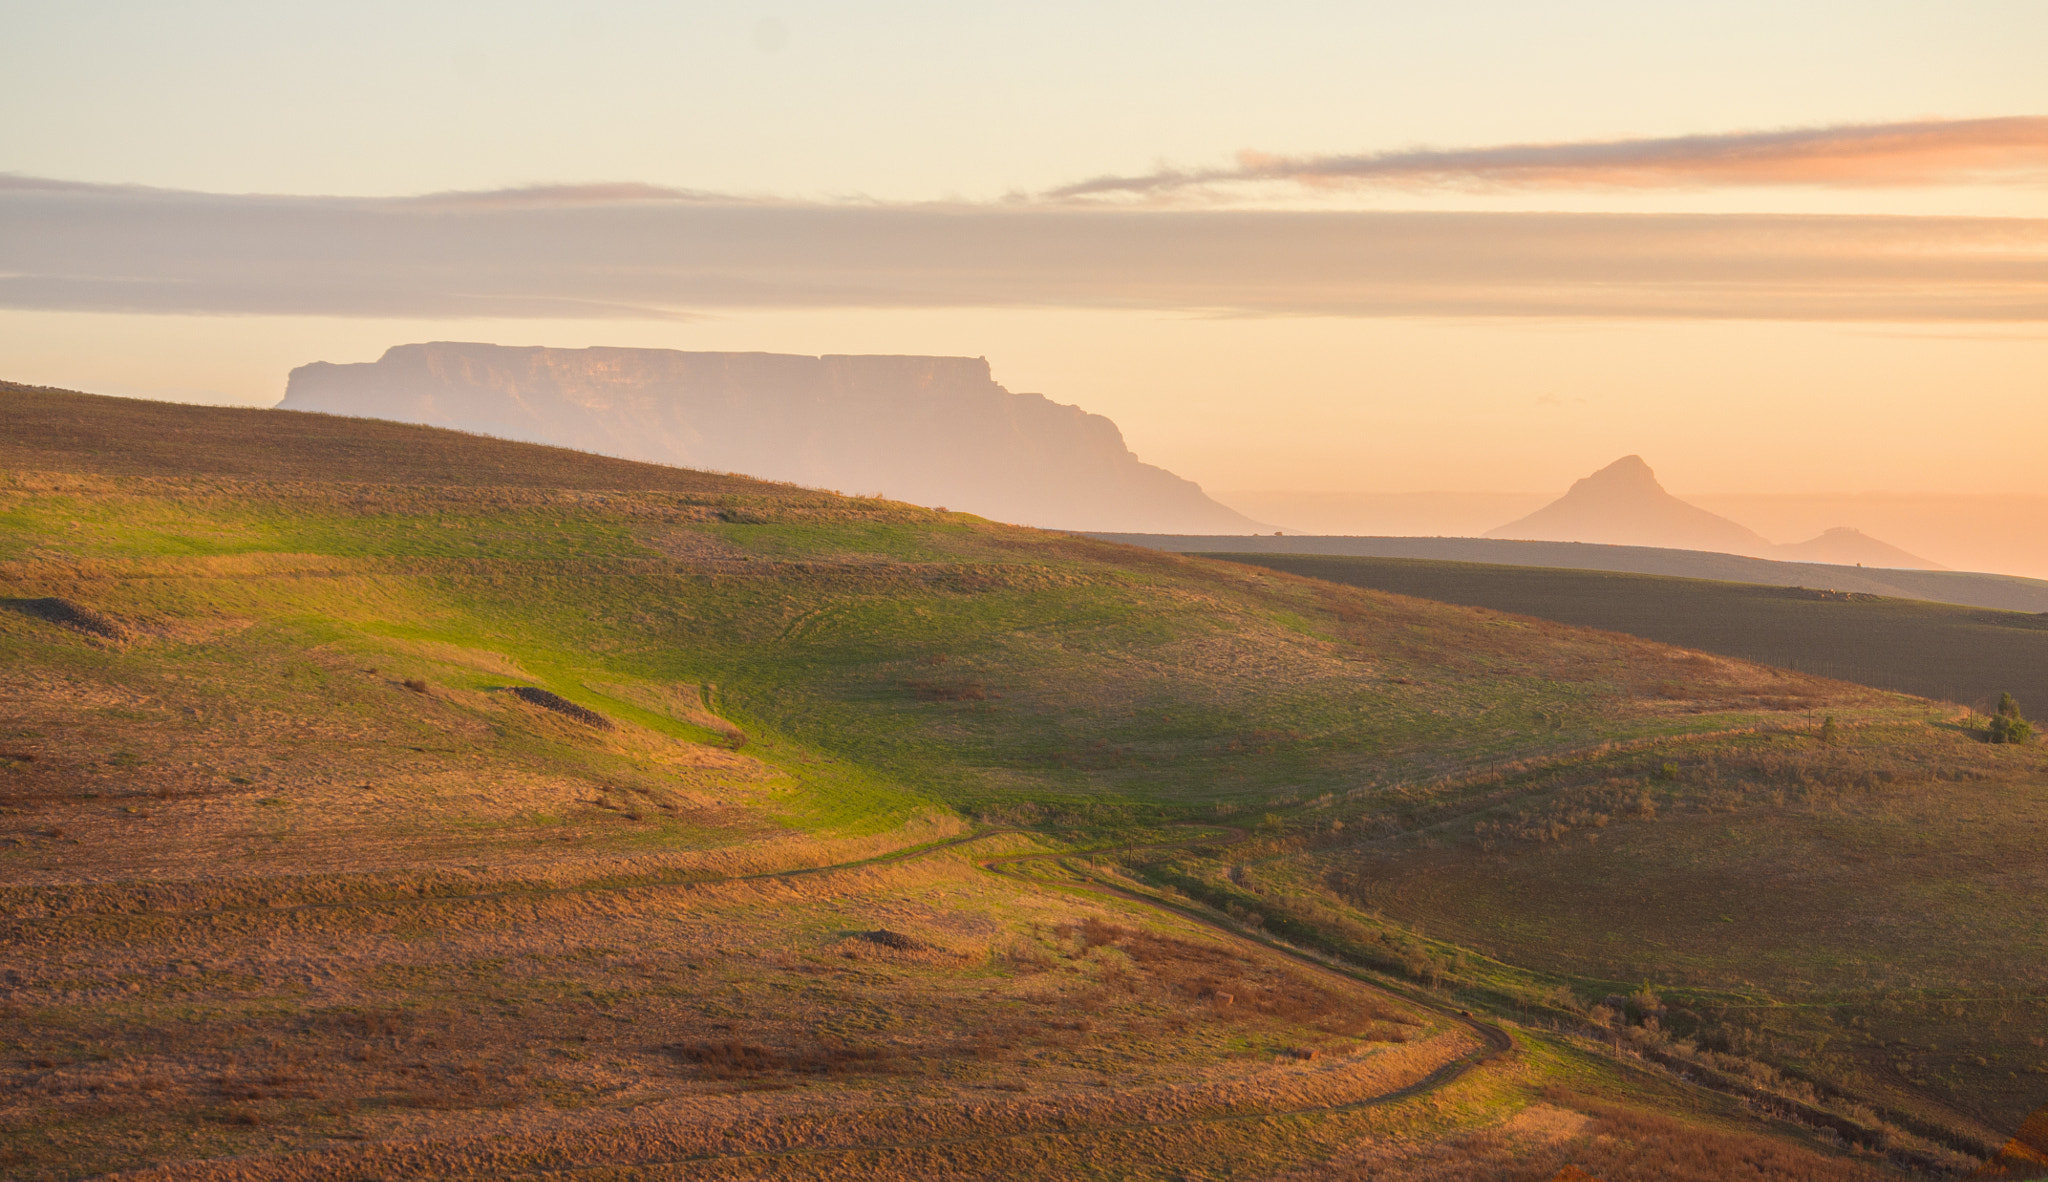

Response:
(1487, 455), (1778, 557)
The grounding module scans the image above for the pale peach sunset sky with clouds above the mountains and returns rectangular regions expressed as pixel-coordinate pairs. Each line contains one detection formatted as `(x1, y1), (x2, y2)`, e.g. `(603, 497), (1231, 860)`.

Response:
(0, 0), (2048, 496)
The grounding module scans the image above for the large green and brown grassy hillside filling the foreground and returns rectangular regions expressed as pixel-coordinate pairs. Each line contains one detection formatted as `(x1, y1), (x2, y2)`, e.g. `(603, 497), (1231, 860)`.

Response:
(0, 389), (2044, 1182)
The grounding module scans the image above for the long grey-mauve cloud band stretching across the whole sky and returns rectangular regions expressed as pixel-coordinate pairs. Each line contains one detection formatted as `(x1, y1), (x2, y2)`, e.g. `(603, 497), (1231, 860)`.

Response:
(0, 178), (2048, 322)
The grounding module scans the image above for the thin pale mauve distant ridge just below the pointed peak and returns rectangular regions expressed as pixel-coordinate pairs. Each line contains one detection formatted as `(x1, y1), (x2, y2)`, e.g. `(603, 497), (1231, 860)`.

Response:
(1090, 533), (2048, 613)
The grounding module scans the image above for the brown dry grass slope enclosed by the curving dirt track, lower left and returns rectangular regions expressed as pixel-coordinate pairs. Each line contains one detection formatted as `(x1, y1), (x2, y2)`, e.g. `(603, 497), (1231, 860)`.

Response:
(0, 835), (1499, 1178)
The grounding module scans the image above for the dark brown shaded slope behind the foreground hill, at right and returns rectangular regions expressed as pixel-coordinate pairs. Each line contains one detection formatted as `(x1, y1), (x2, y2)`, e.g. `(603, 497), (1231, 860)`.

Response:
(1214, 553), (2048, 711)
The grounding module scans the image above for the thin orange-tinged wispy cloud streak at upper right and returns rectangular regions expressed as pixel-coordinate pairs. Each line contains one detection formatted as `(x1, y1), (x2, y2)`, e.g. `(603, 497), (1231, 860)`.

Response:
(1044, 117), (2048, 199)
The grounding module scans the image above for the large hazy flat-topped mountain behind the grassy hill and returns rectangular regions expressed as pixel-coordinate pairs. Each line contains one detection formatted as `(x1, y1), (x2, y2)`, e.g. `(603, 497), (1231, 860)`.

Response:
(279, 342), (1257, 533)
